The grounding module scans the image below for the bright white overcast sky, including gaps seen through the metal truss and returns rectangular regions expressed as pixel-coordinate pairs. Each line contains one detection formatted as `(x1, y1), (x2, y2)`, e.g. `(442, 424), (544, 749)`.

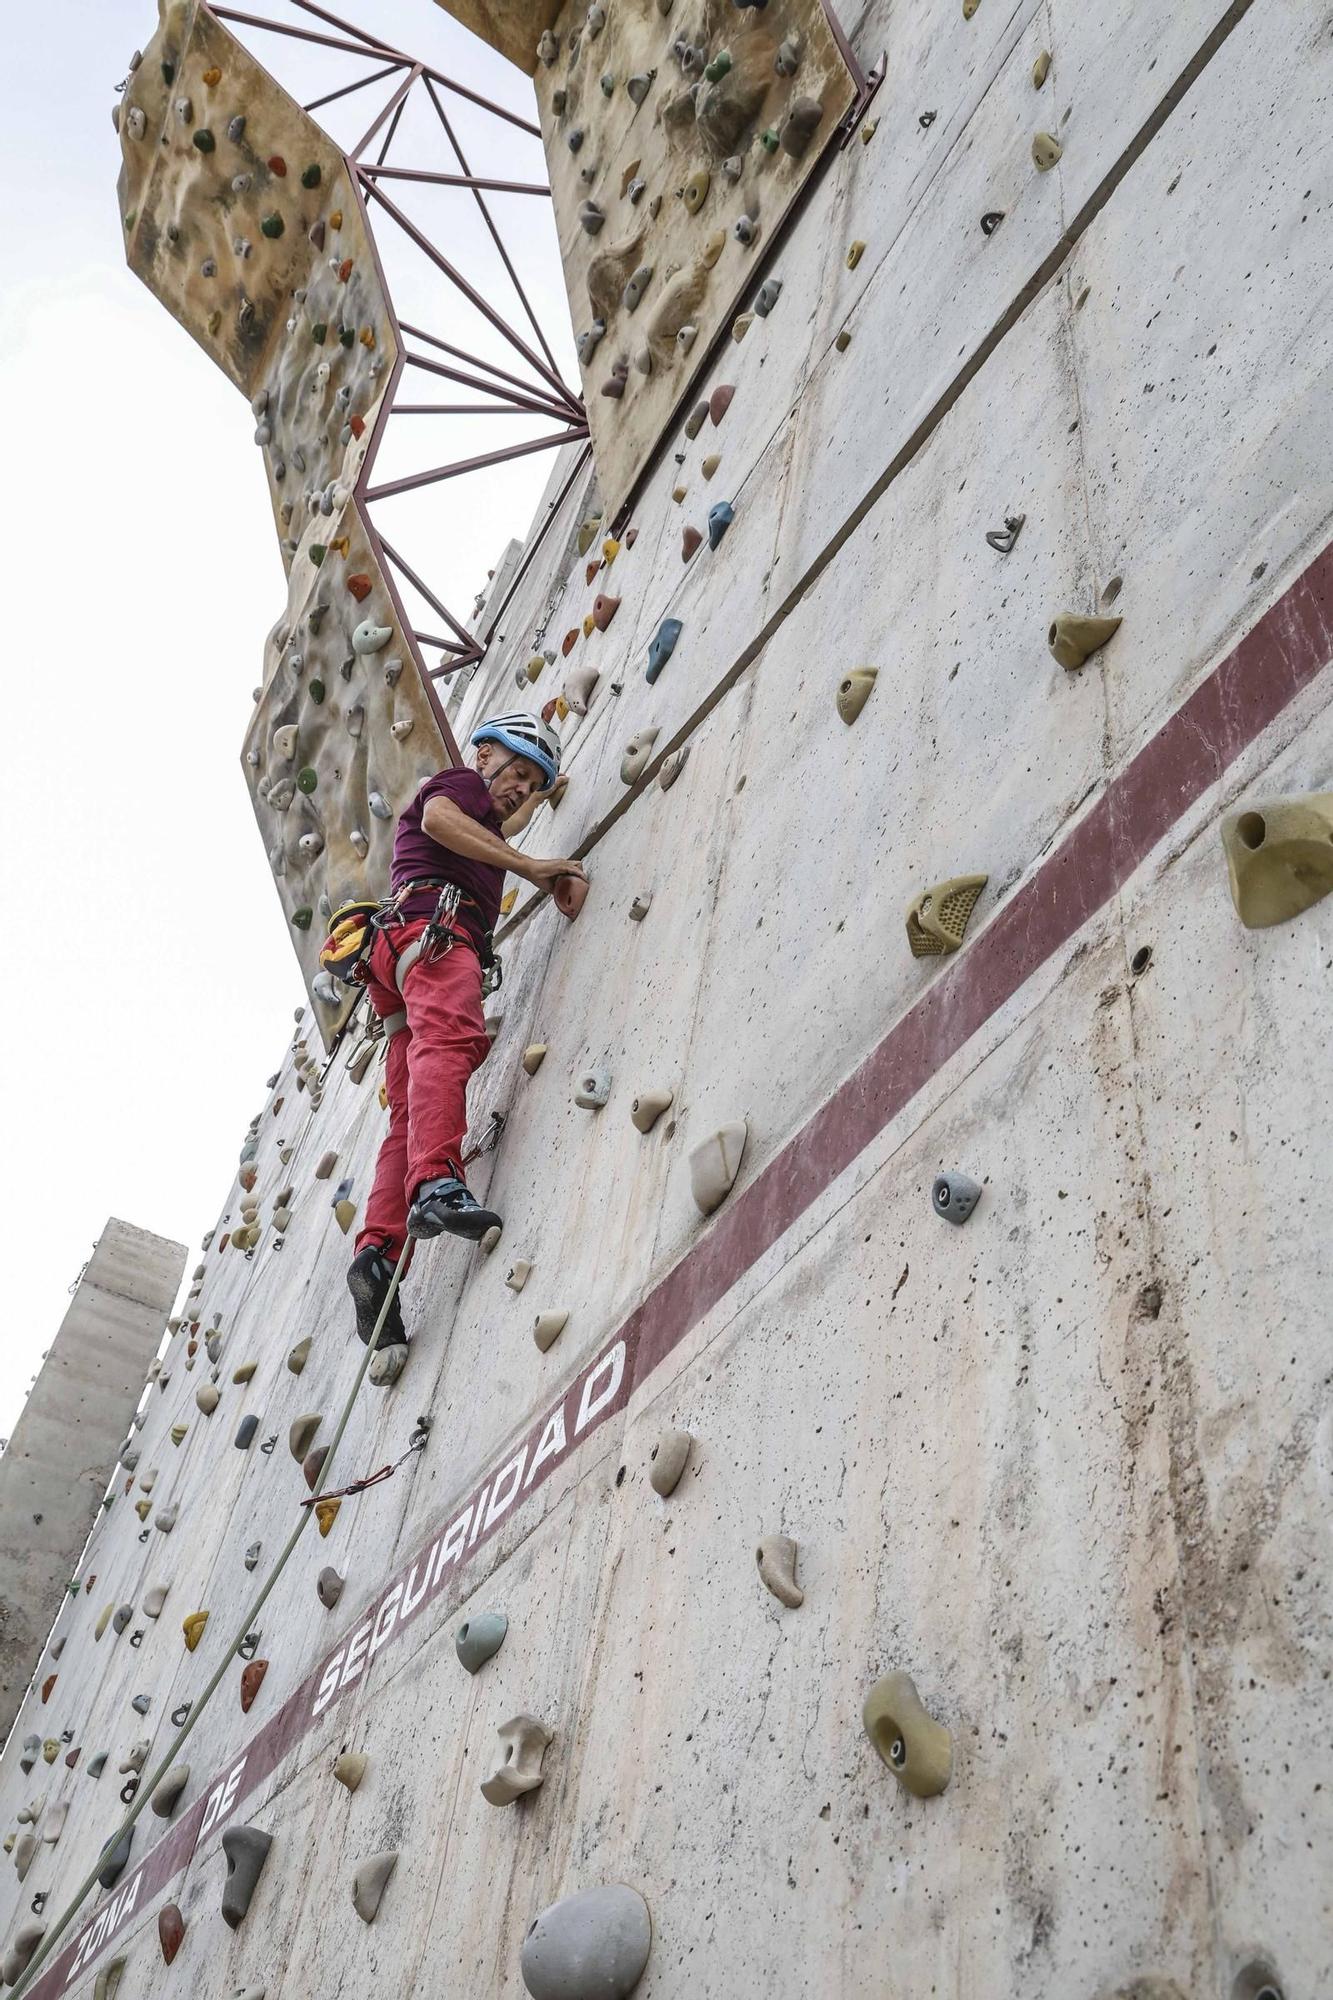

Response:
(0, 0), (576, 1438)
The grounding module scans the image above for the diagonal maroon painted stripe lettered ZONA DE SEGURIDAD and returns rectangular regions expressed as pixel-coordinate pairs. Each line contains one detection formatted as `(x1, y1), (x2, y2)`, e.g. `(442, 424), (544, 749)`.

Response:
(28, 544), (1333, 2000)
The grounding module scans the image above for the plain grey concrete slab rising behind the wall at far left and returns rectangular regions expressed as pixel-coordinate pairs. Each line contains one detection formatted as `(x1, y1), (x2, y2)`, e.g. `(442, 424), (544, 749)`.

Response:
(0, 1216), (186, 1734)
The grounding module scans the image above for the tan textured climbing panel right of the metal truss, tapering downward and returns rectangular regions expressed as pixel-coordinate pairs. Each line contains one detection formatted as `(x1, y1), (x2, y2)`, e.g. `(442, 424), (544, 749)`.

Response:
(536, 0), (857, 516)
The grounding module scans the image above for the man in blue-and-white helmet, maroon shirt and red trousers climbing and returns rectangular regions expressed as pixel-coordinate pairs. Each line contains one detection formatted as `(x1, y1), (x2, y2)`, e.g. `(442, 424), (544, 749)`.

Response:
(346, 714), (584, 1346)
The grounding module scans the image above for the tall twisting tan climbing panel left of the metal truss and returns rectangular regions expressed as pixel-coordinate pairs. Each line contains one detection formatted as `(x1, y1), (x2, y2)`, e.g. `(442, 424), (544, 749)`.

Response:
(116, 4), (448, 1034)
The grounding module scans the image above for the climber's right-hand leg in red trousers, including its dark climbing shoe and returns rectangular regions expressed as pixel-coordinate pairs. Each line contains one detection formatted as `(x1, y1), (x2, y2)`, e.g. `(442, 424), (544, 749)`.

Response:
(402, 944), (500, 1242)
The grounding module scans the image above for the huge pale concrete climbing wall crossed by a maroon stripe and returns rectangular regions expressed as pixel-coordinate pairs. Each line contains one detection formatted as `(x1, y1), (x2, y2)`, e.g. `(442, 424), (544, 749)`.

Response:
(0, 0), (1333, 2000)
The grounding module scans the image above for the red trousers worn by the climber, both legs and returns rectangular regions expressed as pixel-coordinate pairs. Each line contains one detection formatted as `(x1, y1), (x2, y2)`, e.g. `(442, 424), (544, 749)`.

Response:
(356, 918), (490, 1258)
